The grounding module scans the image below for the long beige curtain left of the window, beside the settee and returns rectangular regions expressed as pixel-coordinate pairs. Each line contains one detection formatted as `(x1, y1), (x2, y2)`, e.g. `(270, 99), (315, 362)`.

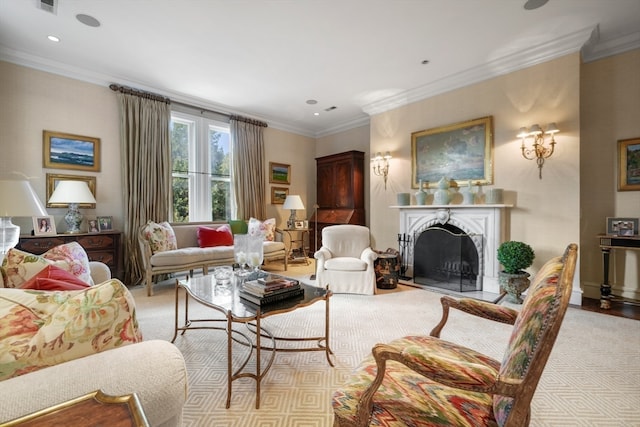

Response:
(111, 85), (171, 285)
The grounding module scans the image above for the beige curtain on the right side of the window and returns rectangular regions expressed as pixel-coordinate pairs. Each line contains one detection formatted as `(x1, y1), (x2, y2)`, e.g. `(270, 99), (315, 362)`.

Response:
(229, 116), (267, 220)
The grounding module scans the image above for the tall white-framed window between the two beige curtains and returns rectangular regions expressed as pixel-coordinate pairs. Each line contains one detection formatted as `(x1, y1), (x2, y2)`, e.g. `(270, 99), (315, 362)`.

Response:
(171, 112), (233, 222)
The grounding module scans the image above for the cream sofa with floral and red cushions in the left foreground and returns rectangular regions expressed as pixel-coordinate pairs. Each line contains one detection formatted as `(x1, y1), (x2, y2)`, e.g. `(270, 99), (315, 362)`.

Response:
(0, 245), (187, 426)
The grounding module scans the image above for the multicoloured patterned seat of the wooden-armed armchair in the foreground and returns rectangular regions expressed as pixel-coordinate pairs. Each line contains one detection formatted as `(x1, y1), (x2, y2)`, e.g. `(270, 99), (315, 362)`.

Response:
(332, 336), (500, 427)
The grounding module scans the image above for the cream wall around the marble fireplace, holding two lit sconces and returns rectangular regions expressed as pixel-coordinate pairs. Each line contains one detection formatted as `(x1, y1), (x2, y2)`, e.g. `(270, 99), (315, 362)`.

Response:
(370, 54), (580, 300)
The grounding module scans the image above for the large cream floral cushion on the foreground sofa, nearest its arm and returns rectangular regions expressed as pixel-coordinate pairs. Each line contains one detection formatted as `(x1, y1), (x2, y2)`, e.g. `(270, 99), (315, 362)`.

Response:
(0, 279), (142, 380)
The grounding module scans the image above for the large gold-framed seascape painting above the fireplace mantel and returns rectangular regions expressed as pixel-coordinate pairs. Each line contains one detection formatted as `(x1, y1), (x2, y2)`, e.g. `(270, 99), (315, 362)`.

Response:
(411, 116), (493, 188)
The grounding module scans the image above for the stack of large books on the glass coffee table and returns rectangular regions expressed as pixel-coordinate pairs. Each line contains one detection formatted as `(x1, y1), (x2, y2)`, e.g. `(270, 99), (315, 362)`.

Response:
(239, 275), (304, 306)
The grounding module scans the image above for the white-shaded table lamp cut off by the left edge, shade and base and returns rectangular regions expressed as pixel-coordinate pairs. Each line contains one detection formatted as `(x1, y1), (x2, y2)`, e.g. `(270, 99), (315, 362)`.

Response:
(0, 179), (47, 260)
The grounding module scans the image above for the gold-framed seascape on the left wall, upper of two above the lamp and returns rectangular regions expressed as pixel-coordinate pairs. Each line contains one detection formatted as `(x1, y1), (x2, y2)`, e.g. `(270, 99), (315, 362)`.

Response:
(42, 130), (100, 172)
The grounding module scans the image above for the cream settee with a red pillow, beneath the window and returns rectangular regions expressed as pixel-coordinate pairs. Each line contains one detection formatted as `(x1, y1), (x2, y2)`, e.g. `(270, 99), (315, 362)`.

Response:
(138, 219), (287, 295)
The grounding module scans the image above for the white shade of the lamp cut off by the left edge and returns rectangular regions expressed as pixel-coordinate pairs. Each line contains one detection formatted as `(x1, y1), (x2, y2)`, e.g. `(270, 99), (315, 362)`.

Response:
(0, 179), (47, 217)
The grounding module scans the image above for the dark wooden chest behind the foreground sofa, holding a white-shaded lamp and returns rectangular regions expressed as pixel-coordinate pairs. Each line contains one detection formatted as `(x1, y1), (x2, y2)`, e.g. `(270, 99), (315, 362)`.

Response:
(16, 231), (122, 280)
